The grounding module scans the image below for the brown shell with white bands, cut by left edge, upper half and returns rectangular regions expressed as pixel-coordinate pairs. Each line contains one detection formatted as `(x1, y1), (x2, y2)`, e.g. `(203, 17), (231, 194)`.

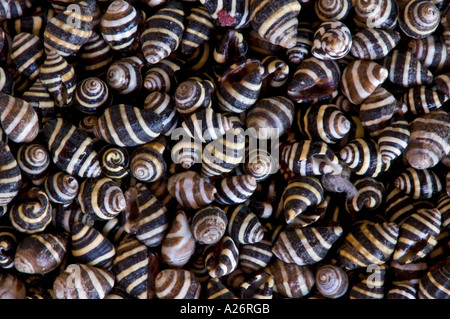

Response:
(0, 92), (39, 143)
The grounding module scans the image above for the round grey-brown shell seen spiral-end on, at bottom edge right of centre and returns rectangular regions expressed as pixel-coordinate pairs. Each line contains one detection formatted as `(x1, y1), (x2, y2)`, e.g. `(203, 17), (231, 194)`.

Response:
(314, 264), (349, 299)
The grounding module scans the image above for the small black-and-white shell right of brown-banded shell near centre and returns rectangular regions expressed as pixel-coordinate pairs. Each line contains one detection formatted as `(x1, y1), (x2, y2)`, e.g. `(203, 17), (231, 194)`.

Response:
(215, 175), (257, 205)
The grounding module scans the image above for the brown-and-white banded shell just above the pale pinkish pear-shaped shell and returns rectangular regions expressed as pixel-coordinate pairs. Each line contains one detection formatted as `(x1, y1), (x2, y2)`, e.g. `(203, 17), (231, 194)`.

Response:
(167, 171), (217, 210)
